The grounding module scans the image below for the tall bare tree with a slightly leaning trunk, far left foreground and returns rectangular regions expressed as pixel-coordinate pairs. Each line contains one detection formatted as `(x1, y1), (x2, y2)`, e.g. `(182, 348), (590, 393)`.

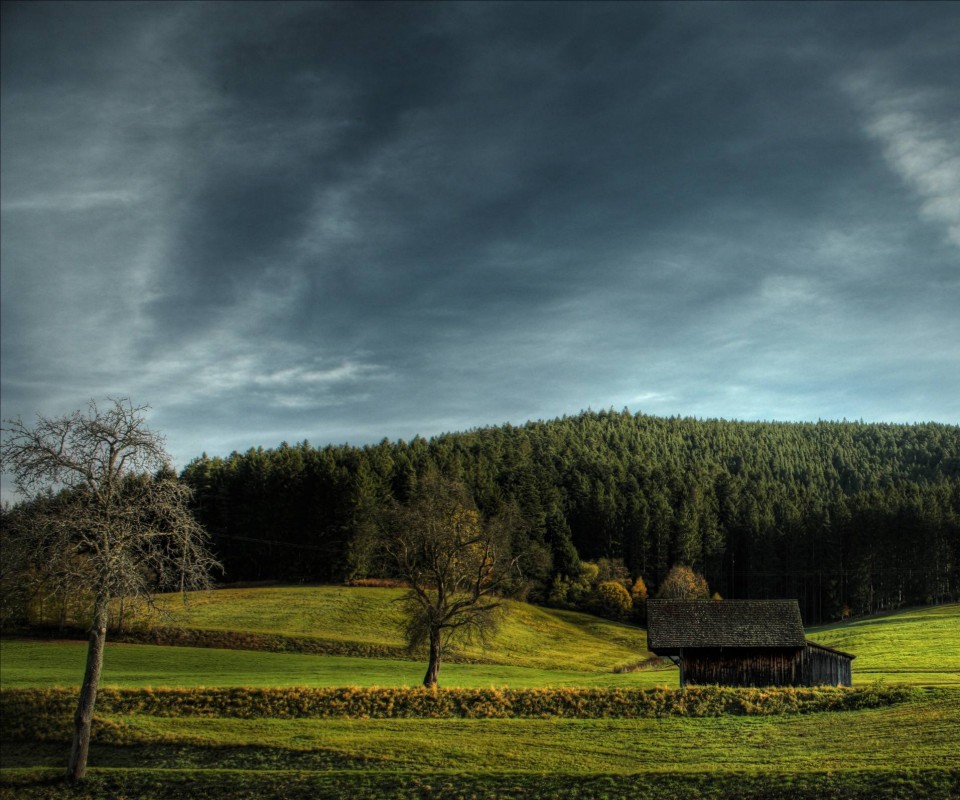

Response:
(2, 399), (219, 781)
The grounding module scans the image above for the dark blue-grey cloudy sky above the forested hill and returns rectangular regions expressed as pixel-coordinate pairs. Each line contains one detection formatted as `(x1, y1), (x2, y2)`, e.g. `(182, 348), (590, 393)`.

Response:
(0, 2), (960, 488)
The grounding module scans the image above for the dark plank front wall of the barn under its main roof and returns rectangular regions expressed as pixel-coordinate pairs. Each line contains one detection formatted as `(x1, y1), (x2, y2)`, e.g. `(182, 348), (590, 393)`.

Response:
(683, 647), (804, 686)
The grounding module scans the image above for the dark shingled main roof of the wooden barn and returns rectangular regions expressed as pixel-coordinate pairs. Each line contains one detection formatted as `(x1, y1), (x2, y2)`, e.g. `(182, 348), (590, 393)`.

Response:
(647, 600), (806, 652)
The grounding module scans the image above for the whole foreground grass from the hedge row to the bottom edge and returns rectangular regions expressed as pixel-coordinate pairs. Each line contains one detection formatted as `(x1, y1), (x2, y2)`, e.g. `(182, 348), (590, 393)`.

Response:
(3, 690), (960, 798)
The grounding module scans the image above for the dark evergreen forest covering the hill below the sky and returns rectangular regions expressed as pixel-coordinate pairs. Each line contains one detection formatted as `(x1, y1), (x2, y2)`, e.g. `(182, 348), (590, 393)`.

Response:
(183, 411), (960, 623)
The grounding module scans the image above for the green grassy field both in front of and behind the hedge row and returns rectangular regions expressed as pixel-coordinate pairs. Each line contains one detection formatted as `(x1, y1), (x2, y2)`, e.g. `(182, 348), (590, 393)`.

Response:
(0, 587), (960, 800)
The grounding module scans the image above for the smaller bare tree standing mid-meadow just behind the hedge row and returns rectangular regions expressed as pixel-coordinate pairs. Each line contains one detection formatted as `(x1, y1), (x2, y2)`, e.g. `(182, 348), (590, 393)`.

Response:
(385, 478), (517, 688)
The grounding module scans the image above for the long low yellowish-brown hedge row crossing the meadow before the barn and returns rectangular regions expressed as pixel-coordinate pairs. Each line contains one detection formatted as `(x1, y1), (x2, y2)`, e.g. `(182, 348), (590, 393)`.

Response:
(0, 685), (914, 738)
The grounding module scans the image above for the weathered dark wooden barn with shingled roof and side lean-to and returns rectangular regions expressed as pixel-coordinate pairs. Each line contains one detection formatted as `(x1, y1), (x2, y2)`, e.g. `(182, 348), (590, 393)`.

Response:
(647, 600), (855, 686)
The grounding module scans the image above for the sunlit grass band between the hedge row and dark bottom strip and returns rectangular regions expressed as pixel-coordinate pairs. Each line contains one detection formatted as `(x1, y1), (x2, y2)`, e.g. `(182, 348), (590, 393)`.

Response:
(62, 690), (960, 774)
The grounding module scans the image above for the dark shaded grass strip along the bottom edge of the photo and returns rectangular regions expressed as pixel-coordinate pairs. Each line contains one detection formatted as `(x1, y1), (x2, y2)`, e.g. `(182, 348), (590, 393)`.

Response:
(0, 764), (960, 800)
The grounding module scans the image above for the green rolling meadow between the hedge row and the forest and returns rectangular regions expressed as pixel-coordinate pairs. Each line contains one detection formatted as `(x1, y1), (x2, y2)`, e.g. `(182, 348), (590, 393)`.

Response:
(0, 586), (960, 688)
